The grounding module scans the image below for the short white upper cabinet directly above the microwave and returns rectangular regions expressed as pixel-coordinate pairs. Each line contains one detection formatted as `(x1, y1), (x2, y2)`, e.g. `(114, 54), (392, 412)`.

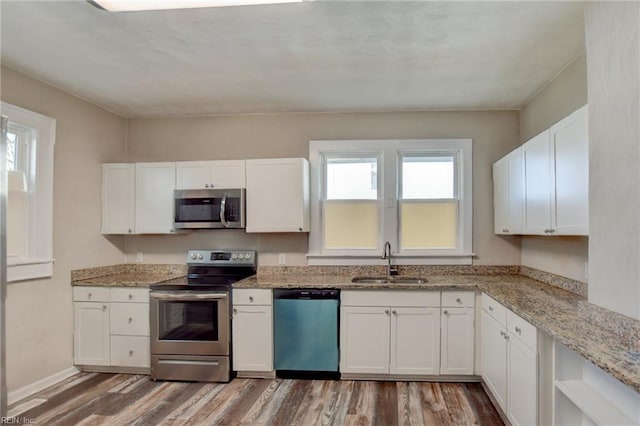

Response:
(176, 160), (246, 189)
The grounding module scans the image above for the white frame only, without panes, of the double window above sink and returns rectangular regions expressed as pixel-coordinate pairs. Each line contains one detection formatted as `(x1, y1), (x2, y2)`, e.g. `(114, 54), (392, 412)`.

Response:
(307, 139), (473, 265)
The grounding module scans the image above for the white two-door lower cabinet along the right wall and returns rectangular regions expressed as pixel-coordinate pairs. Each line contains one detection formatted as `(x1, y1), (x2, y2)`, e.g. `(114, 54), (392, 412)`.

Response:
(481, 294), (539, 425)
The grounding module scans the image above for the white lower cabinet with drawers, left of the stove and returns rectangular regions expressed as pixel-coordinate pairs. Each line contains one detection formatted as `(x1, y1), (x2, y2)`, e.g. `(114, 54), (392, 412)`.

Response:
(73, 287), (150, 370)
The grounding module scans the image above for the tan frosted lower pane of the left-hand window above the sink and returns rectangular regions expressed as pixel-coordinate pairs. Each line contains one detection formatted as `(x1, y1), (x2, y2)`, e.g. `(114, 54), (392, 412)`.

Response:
(324, 201), (378, 249)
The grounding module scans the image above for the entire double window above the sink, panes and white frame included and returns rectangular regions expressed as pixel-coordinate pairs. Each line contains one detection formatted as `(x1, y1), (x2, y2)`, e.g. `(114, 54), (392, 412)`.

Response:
(309, 139), (472, 265)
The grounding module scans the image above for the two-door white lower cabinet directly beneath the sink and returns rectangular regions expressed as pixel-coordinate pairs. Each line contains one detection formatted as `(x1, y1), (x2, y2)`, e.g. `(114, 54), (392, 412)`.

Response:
(340, 290), (440, 375)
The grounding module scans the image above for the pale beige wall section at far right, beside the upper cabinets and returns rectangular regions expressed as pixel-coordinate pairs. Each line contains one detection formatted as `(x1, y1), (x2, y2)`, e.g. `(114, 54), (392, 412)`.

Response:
(586, 2), (640, 319)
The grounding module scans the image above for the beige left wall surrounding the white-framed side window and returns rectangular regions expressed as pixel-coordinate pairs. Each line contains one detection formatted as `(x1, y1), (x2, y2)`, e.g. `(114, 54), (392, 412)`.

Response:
(1, 67), (126, 392)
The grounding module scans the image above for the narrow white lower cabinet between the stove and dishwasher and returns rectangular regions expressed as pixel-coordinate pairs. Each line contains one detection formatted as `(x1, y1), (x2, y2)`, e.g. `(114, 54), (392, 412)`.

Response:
(232, 289), (273, 377)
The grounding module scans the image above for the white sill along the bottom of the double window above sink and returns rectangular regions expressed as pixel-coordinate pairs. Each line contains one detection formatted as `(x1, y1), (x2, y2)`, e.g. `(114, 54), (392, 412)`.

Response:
(307, 253), (475, 266)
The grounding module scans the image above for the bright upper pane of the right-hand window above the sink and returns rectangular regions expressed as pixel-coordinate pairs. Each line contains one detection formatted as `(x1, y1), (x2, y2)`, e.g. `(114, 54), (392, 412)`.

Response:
(401, 156), (455, 200)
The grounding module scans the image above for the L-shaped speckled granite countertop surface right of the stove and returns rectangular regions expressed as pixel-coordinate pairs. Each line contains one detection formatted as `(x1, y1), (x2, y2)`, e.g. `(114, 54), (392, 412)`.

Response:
(234, 274), (640, 392)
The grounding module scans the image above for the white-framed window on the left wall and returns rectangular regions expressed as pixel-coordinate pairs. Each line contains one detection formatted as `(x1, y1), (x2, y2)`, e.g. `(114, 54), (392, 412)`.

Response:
(0, 102), (56, 281)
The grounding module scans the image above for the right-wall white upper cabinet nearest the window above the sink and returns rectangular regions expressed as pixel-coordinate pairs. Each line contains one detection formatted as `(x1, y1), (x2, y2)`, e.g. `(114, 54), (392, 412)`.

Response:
(493, 148), (524, 234)
